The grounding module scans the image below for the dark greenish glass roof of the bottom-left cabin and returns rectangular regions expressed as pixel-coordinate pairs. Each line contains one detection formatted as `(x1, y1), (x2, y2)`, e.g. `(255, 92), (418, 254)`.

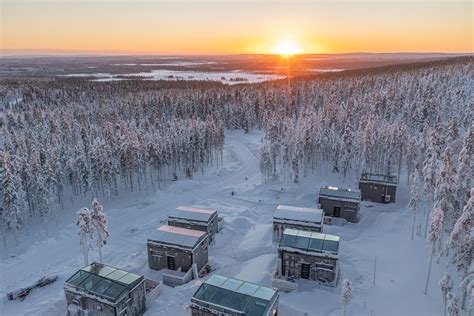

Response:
(65, 262), (143, 303)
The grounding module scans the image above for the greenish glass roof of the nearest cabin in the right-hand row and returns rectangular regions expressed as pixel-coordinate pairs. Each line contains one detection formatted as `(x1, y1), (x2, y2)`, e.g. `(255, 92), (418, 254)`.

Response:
(280, 228), (340, 255)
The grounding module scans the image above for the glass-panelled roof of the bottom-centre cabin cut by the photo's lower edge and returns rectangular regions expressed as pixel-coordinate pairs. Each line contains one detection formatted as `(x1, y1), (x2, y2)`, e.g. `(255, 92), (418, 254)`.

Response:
(191, 274), (278, 316)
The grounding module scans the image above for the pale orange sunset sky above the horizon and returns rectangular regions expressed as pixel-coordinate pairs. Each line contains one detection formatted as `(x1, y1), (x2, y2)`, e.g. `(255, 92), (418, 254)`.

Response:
(0, 0), (474, 54)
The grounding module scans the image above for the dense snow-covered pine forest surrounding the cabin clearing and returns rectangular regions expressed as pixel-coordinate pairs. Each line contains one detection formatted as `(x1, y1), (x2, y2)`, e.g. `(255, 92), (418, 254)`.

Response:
(0, 57), (474, 315)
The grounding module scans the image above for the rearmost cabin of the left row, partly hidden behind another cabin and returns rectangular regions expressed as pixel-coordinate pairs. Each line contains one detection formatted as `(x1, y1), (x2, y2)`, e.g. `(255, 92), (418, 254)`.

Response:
(168, 206), (218, 242)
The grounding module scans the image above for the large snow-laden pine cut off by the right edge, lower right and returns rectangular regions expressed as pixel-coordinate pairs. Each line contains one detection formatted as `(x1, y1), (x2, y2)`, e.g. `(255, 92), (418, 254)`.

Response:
(446, 188), (474, 307)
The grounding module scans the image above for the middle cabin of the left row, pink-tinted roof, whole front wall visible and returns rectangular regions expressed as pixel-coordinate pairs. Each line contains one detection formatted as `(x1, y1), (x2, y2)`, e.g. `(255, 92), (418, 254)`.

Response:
(147, 225), (208, 271)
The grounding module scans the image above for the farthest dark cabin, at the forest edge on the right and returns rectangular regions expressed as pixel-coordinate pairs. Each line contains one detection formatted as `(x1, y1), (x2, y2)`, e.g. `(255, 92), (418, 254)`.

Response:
(359, 173), (398, 203)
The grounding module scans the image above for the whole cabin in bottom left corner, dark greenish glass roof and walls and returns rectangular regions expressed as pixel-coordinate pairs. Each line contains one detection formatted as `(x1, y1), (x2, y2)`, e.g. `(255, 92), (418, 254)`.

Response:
(64, 262), (159, 316)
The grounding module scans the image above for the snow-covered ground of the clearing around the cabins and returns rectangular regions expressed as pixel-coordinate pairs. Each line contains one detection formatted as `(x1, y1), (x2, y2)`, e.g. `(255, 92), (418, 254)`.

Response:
(0, 131), (445, 316)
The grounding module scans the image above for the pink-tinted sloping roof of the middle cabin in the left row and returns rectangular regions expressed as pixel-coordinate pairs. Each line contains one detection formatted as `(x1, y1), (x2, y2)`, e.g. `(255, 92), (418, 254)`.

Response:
(148, 225), (206, 248)
